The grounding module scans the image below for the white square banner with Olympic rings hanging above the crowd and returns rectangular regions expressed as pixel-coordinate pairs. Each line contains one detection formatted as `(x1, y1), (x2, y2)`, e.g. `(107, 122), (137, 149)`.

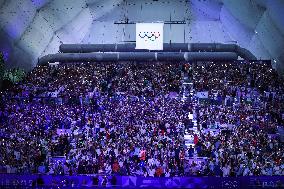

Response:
(136, 23), (164, 50)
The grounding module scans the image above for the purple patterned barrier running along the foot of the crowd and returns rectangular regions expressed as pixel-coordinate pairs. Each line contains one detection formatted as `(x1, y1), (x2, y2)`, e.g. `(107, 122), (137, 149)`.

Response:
(0, 174), (284, 189)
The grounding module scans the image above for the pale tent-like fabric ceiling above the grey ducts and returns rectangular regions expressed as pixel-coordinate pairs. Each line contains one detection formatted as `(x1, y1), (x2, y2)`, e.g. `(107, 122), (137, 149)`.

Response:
(0, 0), (284, 71)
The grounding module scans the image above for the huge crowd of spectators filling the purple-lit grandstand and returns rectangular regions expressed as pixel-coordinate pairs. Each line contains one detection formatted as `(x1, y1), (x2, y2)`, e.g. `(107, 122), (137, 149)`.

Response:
(0, 62), (284, 177)
